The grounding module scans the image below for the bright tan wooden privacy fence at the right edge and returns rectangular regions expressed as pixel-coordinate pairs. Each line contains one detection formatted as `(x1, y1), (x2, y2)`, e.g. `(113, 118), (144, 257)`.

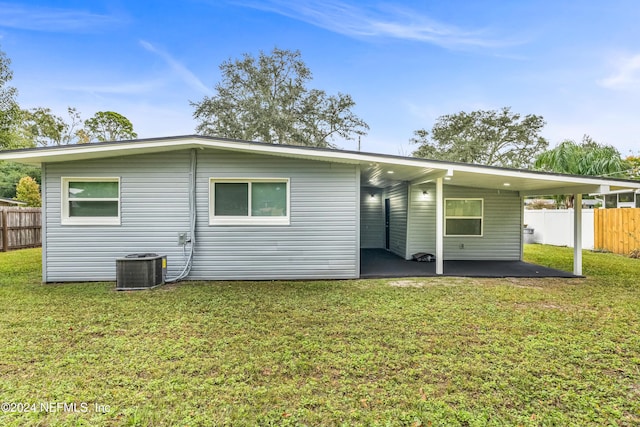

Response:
(593, 208), (640, 255)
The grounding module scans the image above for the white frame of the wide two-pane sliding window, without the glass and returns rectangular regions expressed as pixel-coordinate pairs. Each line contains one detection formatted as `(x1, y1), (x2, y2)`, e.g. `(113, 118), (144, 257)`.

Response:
(209, 178), (291, 225)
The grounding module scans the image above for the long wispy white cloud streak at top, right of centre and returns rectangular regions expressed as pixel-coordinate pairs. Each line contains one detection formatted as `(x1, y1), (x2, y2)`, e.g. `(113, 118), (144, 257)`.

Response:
(232, 0), (515, 48)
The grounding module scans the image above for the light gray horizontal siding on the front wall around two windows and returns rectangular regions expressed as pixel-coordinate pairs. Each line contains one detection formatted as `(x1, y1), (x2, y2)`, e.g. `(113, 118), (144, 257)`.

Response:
(44, 150), (360, 282)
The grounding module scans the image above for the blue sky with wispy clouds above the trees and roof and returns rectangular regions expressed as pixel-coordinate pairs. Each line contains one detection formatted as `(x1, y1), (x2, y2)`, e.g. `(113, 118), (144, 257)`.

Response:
(0, 0), (640, 155)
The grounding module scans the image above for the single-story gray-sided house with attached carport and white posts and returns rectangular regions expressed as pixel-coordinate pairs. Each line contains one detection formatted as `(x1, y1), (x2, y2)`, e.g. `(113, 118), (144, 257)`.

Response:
(0, 136), (640, 282)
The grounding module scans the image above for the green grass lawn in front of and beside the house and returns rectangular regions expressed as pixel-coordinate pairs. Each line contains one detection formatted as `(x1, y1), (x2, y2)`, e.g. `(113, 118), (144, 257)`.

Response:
(0, 245), (640, 426)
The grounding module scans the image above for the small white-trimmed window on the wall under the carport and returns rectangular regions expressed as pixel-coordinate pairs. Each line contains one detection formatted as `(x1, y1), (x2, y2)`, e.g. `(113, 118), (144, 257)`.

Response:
(444, 199), (484, 237)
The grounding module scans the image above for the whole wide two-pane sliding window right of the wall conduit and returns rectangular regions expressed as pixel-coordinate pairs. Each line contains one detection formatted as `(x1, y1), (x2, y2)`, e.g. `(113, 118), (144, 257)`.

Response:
(209, 178), (289, 225)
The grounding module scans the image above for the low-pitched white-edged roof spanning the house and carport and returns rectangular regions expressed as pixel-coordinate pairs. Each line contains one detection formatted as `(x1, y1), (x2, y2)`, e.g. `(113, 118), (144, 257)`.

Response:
(0, 135), (640, 196)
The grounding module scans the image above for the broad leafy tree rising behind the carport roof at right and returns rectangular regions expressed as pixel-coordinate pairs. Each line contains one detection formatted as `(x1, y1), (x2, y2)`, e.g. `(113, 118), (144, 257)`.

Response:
(411, 107), (549, 168)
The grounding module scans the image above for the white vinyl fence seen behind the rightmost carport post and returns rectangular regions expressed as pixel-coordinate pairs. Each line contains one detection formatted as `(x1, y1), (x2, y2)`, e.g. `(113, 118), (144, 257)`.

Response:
(524, 209), (593, 249)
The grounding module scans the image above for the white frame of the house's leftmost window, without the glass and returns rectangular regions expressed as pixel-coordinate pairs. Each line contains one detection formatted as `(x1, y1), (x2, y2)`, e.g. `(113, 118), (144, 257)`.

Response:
(60, 176), (122, 225)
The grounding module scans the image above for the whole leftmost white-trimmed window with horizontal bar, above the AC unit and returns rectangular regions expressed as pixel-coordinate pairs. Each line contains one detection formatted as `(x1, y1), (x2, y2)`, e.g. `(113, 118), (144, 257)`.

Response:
(61, 178), (120, 225)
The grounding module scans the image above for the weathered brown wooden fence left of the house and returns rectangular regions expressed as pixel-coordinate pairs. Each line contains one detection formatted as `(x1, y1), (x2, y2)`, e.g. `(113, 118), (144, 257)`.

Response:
(0, 207), (42, 252)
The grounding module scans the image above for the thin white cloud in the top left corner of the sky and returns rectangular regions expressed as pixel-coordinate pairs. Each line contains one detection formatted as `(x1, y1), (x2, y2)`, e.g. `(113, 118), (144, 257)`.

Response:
(0, 2), (123, 32)
